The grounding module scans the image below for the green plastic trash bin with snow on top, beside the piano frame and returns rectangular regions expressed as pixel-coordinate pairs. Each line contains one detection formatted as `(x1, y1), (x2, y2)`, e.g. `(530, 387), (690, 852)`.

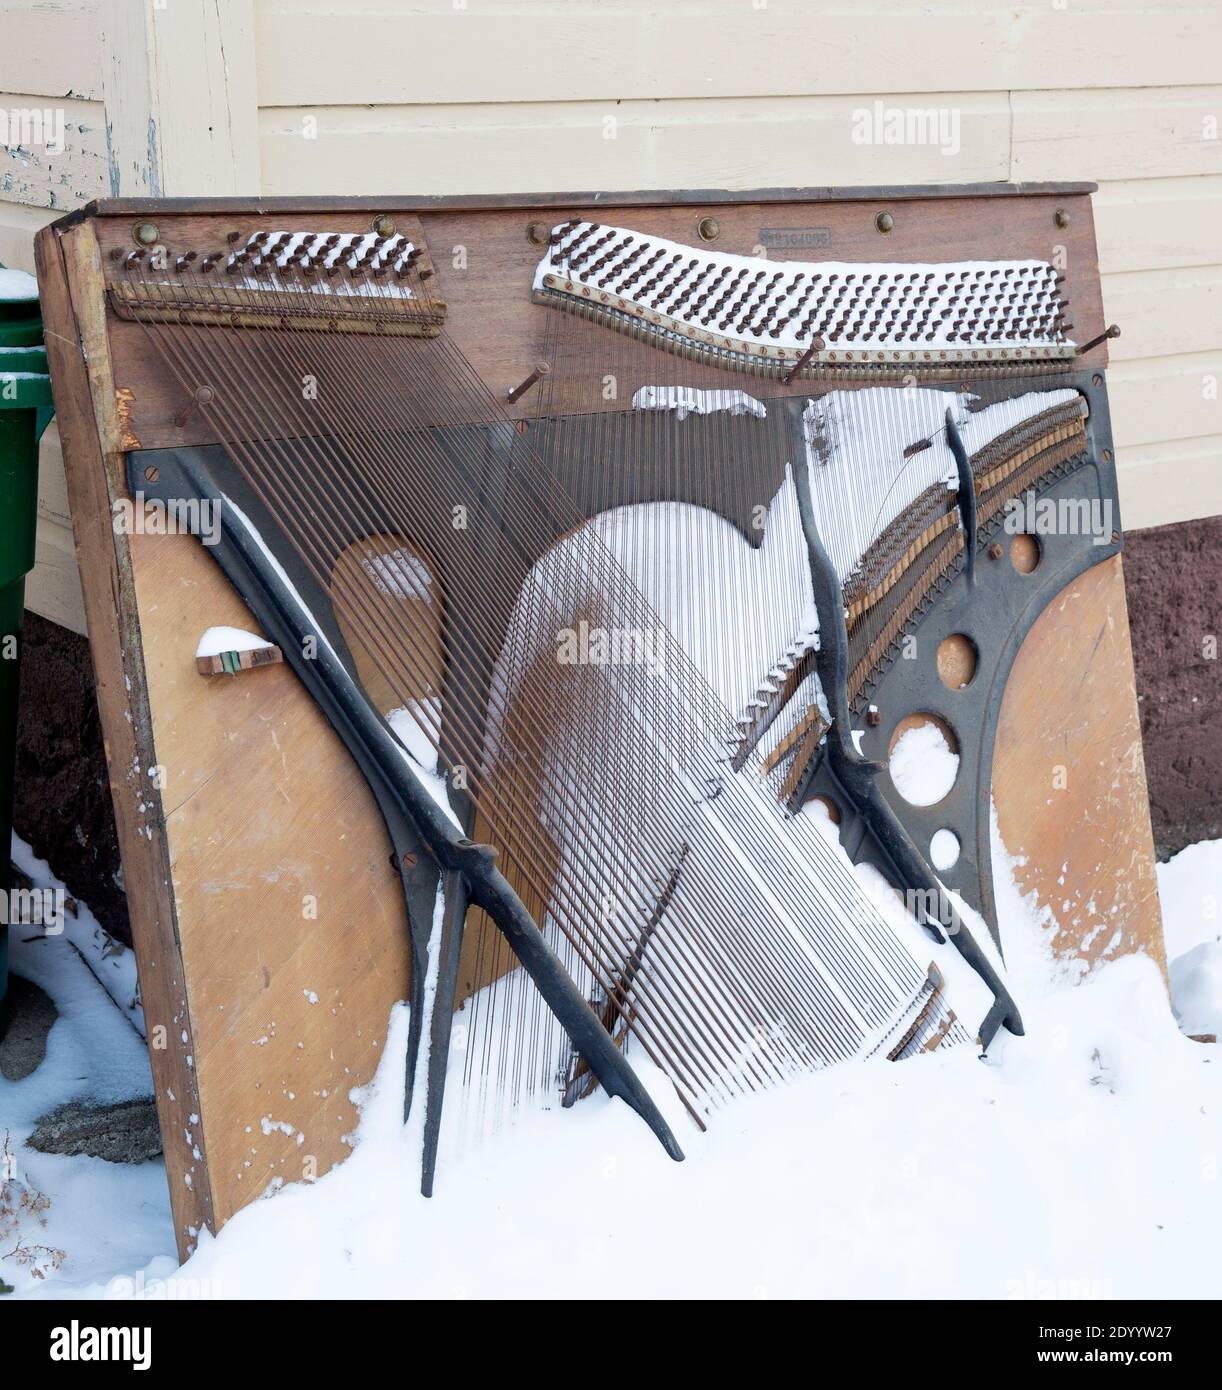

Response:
(0, 265), (51, 1031)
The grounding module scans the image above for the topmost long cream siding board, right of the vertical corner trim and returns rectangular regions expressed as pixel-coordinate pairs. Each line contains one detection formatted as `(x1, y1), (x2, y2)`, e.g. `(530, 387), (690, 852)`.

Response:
(256, 0), (1222, 106)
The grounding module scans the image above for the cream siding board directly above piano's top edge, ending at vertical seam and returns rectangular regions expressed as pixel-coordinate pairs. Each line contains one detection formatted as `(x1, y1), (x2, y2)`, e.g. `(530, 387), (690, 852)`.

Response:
(260, 93), (1011, 195)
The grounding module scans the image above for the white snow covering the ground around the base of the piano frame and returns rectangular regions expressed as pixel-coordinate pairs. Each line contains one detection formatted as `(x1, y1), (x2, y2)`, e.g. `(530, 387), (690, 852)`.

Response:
(0, 817), (1222, 1298)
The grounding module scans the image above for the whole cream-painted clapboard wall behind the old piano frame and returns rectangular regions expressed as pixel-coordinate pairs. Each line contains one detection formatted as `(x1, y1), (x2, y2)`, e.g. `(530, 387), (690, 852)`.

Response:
(0, 0), (1222, 627)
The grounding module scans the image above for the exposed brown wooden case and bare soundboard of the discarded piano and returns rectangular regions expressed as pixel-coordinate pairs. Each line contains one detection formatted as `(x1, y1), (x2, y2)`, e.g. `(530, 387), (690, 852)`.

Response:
(38, 186), (1162, 1254)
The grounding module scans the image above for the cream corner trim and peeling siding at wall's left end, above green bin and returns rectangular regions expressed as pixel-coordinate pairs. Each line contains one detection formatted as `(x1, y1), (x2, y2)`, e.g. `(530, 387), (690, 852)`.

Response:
(0, 0), (260, 632)
